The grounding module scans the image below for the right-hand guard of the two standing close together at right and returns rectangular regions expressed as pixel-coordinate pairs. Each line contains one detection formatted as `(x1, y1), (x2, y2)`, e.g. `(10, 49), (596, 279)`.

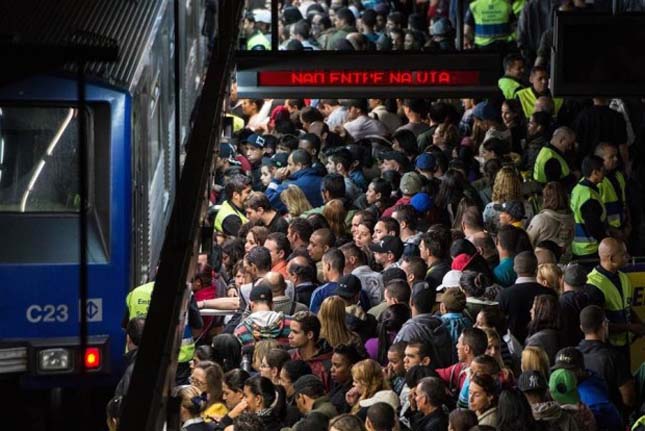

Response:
(594, 142), (631, 239)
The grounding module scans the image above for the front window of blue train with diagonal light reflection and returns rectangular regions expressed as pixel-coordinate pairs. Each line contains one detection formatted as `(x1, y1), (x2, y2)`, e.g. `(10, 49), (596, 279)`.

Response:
(0, 106), (80, 212)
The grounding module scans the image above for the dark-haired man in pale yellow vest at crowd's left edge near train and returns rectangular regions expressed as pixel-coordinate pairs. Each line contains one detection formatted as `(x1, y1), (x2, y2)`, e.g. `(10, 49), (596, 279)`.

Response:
(213, 175), (251, 236)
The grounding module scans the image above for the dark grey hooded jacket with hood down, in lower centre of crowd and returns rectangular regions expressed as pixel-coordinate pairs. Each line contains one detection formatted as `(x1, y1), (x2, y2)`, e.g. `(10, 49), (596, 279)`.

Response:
(394, 313), (450, 368)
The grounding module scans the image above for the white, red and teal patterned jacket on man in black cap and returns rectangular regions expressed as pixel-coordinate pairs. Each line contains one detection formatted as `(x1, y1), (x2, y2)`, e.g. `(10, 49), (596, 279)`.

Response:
(234, 310), (291, 347)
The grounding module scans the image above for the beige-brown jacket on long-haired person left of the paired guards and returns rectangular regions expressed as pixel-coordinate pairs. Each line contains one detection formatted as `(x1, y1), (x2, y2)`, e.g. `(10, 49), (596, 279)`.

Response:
(526, 209), (575, 248)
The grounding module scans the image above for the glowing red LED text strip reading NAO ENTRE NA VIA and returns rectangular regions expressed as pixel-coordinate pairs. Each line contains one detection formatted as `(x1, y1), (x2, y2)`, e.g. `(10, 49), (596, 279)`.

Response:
(257, 70), (480, 87)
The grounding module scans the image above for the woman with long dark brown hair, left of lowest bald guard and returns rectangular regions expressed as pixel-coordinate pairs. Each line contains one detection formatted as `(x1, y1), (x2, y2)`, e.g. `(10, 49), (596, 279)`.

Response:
(526, 295), (560, 365)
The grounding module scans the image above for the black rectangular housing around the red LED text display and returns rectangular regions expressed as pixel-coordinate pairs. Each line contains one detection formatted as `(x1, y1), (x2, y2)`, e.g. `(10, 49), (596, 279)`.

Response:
(236, 51), (503, 99)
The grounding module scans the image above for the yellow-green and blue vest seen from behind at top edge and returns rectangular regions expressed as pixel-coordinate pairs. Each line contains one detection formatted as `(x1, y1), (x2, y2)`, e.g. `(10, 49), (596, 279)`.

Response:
(470, 0), (513, 46)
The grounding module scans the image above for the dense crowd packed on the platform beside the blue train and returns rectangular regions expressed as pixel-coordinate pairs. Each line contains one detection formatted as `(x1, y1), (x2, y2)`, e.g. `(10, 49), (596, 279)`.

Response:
(107, 0), (645, 431)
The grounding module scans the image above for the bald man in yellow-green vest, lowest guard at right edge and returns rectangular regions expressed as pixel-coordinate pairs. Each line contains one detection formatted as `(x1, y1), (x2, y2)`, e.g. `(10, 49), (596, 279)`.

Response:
(585, 238), (645, 358)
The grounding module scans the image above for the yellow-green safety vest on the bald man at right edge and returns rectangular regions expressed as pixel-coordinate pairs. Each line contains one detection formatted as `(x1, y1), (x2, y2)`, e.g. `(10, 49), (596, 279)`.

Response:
(587, 269), (633, 347)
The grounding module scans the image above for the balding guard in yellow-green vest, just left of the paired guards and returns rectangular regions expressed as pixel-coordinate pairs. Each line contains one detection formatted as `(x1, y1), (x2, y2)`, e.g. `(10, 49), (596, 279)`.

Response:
(533, 127), (576, 190)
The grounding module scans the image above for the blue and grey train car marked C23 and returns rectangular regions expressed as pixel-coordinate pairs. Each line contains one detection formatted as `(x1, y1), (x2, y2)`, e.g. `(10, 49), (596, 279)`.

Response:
(0, 0), (207, 388)
